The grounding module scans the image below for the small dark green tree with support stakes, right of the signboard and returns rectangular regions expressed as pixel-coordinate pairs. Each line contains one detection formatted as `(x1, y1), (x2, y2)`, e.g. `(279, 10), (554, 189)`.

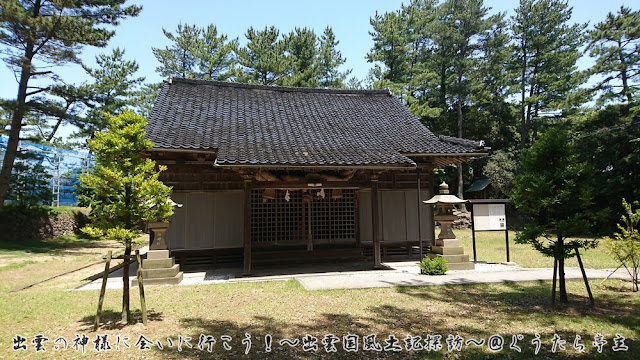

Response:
(510, 128), (597, 303)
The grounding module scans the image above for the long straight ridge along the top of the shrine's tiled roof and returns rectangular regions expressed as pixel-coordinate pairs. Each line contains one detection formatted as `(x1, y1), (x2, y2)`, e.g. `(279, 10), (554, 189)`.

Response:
(164, 76), (392, 96)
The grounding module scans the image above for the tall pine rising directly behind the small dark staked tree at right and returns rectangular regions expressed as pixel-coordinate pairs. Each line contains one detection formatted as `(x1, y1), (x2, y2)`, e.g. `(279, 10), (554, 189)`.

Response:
(511, 0), (586, 149)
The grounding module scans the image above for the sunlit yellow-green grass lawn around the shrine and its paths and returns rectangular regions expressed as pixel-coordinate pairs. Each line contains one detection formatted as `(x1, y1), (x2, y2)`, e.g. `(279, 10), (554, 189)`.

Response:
(0, 231), (640, 359)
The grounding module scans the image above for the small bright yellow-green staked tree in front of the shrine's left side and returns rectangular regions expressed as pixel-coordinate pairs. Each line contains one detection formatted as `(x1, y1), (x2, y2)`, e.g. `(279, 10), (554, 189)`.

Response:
(80, 110), (173, 323)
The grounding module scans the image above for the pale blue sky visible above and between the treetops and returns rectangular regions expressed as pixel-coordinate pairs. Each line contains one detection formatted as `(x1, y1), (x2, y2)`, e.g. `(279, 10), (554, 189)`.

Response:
(0, 0), (637, 107)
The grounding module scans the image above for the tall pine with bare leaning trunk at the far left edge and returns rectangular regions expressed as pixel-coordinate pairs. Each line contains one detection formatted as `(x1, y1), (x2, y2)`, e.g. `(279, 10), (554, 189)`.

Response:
(0, 0), (141, 211)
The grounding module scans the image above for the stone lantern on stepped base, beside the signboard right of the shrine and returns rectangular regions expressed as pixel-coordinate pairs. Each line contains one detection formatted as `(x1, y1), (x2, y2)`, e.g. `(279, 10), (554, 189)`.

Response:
(423, 182), (475, 270)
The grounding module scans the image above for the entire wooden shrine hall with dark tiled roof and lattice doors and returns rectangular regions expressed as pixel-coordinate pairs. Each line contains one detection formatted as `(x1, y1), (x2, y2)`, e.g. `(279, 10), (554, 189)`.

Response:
(146, 78), (487, 274)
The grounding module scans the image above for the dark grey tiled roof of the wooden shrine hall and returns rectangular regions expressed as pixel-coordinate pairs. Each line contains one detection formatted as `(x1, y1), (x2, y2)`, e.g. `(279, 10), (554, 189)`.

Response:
(146, 78), (480, 166)
